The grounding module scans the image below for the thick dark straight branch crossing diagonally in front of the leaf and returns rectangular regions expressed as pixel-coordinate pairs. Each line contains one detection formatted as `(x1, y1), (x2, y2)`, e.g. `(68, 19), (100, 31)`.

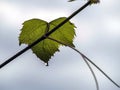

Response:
(0, 0), (91, 69)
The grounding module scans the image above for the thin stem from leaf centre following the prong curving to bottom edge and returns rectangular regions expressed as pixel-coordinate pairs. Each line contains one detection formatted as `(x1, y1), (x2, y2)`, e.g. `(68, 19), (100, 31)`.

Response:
(47, 37), (99, 90)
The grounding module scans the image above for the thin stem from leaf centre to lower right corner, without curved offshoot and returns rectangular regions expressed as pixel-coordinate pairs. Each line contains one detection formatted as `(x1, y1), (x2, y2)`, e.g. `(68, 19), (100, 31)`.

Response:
(47, 37), (120, 88)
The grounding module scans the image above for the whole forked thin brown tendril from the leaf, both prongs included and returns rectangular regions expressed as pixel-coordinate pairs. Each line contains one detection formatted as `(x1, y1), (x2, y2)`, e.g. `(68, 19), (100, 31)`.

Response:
(47, 37), (120, 89)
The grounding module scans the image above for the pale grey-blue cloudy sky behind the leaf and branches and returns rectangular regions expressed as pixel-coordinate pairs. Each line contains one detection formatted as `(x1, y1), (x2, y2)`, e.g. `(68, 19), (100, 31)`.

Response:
(0, 0), (120, 90)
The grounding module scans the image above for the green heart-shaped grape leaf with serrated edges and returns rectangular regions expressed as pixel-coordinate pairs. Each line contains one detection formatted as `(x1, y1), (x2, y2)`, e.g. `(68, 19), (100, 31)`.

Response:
(19, 17), (75, 63)
